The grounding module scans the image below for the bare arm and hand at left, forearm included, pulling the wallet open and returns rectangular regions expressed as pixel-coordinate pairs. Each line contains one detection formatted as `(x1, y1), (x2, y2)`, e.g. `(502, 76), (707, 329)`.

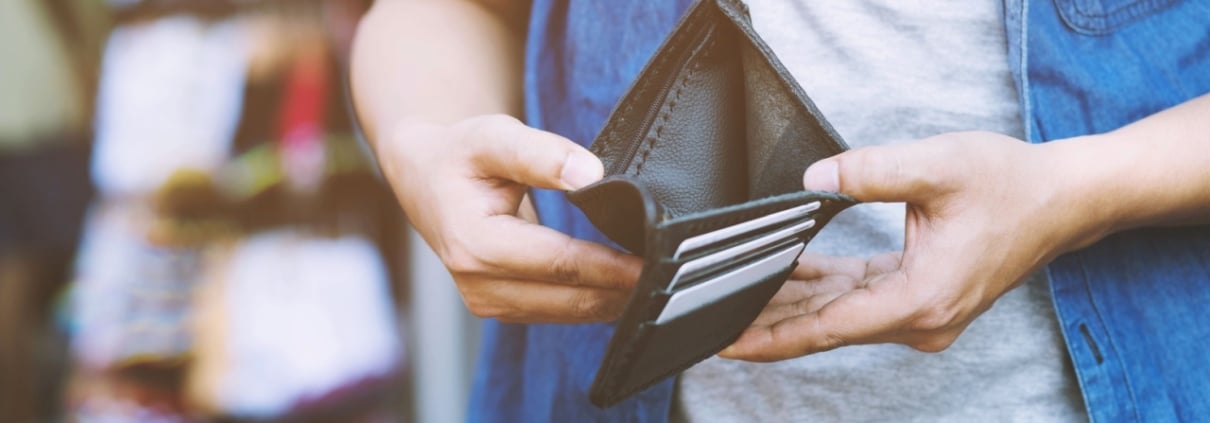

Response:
(351, 0), (641, 323)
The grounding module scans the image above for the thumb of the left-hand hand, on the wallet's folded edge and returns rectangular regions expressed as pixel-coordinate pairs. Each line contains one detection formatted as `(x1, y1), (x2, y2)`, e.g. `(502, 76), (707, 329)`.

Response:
(463, 116), (605, 190)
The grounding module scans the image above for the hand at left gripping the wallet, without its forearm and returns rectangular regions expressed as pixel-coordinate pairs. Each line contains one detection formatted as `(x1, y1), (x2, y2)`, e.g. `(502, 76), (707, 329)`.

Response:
(376, 115), (643, 323)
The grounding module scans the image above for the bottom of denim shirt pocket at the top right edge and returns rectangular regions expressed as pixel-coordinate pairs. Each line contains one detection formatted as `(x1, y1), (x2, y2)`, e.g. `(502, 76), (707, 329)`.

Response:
(1055, 0), (1181, 35)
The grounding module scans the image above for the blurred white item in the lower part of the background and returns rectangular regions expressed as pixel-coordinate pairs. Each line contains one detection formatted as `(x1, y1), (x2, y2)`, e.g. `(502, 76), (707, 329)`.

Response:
(189, 230), (402, 418)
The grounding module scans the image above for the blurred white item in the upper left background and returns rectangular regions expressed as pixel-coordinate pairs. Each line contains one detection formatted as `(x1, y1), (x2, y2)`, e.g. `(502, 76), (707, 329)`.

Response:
(92, 16), (249, 198)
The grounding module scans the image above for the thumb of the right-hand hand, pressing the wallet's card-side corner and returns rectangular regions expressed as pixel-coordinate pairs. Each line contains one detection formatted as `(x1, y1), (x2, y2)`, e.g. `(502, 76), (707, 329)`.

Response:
(802, 143), (945, 203)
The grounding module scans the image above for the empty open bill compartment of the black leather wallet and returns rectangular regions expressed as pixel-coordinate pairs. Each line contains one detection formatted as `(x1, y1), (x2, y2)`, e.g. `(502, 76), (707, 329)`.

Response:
(567, 0), (847, 255)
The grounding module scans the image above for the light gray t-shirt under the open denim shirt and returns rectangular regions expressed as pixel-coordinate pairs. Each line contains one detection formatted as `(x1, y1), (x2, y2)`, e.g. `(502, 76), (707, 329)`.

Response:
(674, 0), (1087, 422)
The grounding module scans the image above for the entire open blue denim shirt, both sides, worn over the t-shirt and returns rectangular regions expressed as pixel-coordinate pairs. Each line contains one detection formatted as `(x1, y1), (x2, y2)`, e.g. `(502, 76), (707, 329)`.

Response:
(469, 0), (1210, 422)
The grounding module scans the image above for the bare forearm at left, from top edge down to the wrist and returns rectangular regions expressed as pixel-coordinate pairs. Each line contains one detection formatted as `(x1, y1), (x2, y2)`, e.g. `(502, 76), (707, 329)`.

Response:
(352, 0), (523, 143)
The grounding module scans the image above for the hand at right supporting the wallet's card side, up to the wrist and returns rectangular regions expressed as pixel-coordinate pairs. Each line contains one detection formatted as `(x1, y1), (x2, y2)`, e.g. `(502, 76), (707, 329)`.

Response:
(720, 133), (1108, 361)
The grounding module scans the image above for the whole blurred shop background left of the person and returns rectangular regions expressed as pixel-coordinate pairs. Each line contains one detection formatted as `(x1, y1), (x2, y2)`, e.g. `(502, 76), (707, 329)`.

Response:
(0, 0), (478, 423)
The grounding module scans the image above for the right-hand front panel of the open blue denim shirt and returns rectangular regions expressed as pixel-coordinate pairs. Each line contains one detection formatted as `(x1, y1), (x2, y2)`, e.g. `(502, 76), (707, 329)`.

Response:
(1006, 0), (1210, 422)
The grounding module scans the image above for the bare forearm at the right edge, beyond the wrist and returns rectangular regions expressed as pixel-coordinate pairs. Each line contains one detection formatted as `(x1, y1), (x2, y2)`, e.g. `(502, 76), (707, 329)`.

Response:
(1044, 94), (1210, 241)
